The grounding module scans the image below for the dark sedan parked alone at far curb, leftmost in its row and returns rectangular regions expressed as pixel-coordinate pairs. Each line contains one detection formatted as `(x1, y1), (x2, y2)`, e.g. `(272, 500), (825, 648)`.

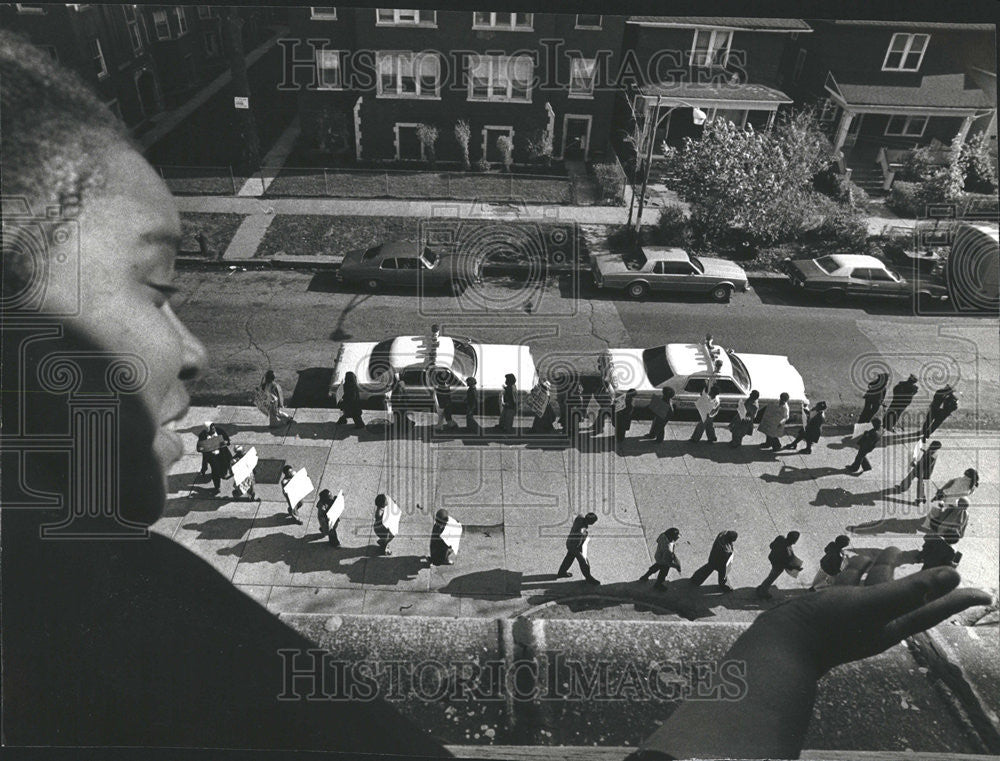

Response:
(337, 240), (478, 291)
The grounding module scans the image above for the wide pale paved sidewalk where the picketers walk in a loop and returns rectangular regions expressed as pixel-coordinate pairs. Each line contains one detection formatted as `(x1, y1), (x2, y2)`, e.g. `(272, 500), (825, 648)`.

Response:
(154, 400), (1000, 621)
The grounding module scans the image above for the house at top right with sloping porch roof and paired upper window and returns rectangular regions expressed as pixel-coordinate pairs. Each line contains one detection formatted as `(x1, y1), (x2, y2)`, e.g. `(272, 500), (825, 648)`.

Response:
(786, 20), (996, 185)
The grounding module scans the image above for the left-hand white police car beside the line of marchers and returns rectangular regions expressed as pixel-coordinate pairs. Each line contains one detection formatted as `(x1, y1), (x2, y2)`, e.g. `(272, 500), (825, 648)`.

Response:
(330, 336), (538, 406)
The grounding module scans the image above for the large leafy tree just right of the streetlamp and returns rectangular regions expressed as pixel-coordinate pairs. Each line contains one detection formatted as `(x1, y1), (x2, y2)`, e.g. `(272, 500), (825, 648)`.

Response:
(664, 109), (835, 243)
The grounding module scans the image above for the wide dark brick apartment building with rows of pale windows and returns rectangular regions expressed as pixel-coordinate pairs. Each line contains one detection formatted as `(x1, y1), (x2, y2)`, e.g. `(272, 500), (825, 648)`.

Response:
(285, 6), (624, 163)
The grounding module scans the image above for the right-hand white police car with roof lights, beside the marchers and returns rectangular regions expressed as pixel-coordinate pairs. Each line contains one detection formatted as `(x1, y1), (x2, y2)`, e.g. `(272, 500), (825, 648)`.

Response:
(608, 343), (809, 420)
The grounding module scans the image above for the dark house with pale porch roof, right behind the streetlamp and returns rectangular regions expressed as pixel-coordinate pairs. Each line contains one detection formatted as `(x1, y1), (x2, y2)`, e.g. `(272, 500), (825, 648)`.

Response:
(618, 16), (811, 154)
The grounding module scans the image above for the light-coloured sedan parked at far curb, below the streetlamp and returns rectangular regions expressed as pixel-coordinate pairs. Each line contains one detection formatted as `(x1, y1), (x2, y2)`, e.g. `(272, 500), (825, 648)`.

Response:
(590, 246), (750, 302)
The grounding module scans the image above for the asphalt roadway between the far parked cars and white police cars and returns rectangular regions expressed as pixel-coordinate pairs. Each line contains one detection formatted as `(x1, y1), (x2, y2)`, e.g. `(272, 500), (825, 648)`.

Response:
(175, 271), (1000, 429)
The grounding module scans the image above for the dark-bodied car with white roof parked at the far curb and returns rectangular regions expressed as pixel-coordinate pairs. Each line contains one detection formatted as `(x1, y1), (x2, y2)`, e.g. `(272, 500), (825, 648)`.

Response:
(782, 254), (948, 304)
